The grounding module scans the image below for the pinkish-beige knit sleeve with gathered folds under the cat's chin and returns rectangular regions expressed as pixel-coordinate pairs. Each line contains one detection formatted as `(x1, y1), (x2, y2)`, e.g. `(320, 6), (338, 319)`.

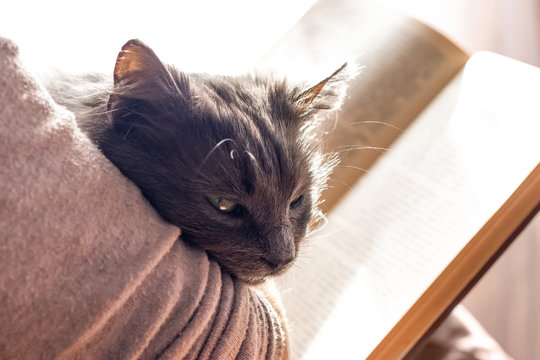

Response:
(0, 38), (288, 359)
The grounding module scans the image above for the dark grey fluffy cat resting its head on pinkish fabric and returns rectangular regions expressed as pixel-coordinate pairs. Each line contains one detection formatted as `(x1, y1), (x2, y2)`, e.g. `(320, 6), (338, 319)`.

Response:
(47, 39), (347, 284)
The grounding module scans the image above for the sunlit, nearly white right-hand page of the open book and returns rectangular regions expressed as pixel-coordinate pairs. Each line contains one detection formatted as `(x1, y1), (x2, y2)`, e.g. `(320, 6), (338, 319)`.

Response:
(281, 54), (540, 359)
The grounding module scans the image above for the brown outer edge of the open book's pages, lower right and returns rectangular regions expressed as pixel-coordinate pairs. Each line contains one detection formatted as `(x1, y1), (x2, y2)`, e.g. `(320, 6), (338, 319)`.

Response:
(367, 165), (540, 360)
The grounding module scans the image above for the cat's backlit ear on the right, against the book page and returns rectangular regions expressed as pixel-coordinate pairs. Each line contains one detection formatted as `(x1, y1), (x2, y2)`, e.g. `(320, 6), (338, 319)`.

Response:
(296, 63), (354, 113)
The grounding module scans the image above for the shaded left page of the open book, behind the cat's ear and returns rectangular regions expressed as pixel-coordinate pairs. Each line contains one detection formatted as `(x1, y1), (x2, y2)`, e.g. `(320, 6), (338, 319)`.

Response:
(259, 0), (468, 211)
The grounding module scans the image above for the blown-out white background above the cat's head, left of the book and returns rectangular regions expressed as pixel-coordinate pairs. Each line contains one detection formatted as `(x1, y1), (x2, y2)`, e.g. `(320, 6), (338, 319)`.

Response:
(0, 0), (315, 73)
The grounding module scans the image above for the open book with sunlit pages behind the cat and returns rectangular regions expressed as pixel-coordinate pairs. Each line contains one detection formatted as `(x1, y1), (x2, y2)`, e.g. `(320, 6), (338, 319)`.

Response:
(259, 0), (540, 360)
